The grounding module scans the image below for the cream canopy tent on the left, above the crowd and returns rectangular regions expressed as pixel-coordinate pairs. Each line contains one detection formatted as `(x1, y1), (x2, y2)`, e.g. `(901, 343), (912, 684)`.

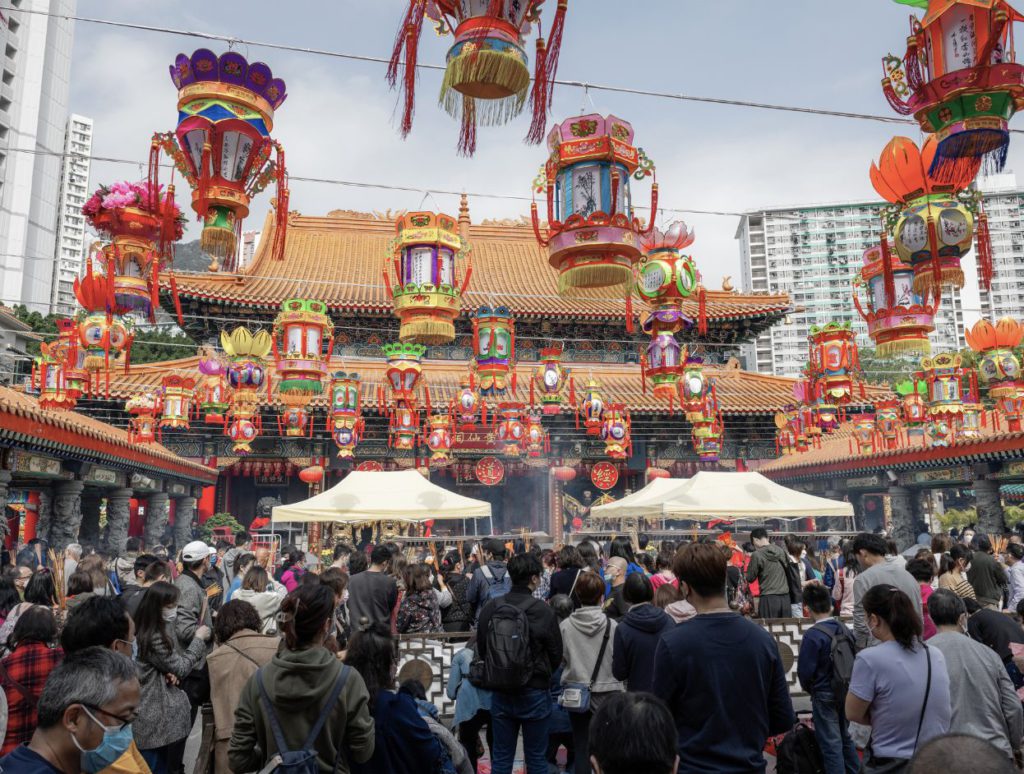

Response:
(270, 470), (493, 531)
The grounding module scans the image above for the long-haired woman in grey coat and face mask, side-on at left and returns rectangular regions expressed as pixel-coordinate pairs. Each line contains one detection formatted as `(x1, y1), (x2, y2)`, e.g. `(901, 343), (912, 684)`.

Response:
(135, 582), (211, 774)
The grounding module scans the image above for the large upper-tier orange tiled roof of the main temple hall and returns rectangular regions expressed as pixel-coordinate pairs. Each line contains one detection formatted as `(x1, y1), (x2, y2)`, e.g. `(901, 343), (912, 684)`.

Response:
(164, 206), (794, 320)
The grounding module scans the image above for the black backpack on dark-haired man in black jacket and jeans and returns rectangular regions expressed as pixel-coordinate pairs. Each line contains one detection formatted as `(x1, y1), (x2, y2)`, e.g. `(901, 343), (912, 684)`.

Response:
(470, 599), (538, 692)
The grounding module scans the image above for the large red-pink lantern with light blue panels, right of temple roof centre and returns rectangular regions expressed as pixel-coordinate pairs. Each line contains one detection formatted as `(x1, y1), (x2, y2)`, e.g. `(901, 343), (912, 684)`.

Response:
(531, 114), (657, 296)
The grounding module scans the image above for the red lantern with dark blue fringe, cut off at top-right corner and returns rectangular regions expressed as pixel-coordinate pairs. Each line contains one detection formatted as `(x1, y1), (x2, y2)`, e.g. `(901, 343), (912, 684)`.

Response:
(882, 0), (1024, 179)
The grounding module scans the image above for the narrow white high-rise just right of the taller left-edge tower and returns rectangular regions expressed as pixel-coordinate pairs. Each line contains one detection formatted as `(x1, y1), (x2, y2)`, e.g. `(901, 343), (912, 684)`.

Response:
(50, 114), (92, 316)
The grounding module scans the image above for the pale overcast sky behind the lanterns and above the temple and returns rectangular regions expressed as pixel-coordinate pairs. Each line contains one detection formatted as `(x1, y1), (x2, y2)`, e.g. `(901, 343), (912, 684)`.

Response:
(71, 0), (1024, 288)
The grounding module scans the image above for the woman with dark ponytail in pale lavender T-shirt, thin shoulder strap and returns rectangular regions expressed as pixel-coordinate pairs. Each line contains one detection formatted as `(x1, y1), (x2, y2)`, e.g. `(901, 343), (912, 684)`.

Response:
(846, 585), (950, 774)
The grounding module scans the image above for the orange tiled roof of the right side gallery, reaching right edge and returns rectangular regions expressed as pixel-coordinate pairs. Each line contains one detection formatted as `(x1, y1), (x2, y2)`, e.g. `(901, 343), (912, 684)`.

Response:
(758, 413), (1024, 481)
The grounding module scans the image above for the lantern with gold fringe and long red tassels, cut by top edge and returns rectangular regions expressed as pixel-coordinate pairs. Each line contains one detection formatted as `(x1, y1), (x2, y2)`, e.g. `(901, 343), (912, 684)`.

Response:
(387, 0), (568, 156)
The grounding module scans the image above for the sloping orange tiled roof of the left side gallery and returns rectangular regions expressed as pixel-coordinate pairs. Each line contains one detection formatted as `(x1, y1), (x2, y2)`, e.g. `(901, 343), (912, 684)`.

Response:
(0, 387), (217, 483)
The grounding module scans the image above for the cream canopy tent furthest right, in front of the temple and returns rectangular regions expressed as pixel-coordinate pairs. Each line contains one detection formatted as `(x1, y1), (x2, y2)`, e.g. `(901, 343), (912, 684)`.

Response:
(660, 471), (853, 521)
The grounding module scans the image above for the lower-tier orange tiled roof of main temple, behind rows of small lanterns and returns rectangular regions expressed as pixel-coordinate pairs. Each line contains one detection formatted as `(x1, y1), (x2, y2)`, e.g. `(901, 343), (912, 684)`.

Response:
(111, 356), (888, 415)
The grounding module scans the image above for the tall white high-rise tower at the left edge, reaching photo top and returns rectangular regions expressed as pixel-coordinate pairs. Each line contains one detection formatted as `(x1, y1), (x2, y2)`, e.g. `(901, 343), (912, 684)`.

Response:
(0, 0), (76, 313)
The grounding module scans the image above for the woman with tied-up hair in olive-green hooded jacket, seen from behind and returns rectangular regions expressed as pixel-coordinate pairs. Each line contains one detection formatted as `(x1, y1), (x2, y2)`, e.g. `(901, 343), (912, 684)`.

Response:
(227, 584), (374, 774)
